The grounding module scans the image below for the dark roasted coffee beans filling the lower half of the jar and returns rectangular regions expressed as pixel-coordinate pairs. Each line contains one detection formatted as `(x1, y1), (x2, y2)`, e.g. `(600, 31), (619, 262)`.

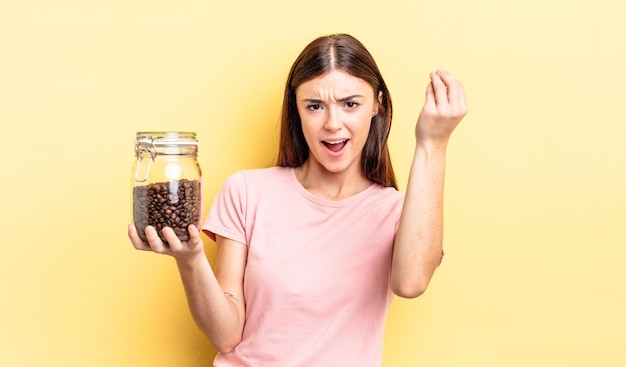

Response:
(133, 179), (202, 243)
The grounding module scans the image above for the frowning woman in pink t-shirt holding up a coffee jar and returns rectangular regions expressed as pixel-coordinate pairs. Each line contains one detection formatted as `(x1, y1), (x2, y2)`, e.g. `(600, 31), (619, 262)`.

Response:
(129, 34), (467, 367)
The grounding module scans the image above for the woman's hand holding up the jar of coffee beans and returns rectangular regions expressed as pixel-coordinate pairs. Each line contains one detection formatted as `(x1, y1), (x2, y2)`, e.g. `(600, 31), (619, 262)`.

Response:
(128, 224), (204, 261)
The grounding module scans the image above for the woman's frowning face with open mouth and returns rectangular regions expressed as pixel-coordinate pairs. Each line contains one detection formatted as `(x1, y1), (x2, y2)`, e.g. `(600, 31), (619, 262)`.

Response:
(296, 70), (378, 178)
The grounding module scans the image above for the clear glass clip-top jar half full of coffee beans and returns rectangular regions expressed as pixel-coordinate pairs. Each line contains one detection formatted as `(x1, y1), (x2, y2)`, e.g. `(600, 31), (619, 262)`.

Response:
(131, 131), (202, 243)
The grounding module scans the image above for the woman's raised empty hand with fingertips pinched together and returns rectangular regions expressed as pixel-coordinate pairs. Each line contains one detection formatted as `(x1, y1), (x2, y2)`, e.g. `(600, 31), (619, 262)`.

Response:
(415, 69), (467, 145)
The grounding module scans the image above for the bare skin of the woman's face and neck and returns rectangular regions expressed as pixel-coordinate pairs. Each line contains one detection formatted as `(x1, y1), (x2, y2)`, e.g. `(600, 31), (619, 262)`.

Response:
(296, 71), (379, 200)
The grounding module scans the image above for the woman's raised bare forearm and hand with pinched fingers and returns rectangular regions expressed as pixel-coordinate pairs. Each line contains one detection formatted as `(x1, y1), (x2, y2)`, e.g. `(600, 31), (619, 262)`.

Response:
(391, 69), (467, 298)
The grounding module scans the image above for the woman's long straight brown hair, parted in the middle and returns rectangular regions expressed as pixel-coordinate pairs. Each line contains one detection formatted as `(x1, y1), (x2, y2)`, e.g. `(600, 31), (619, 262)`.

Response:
(276, 34), (398, 189)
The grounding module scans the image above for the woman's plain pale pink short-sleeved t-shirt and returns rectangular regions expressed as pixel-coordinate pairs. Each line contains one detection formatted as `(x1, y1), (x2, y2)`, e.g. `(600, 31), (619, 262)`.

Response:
(202, 167), (404, 367)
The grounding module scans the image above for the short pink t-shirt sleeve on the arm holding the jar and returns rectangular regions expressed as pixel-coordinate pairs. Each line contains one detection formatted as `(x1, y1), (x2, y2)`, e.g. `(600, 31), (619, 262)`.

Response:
(202, 171), (247, 244)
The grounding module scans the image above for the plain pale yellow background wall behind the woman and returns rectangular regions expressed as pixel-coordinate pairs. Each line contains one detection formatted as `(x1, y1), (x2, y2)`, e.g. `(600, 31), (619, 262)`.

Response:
(0, 0), (626, 367)
